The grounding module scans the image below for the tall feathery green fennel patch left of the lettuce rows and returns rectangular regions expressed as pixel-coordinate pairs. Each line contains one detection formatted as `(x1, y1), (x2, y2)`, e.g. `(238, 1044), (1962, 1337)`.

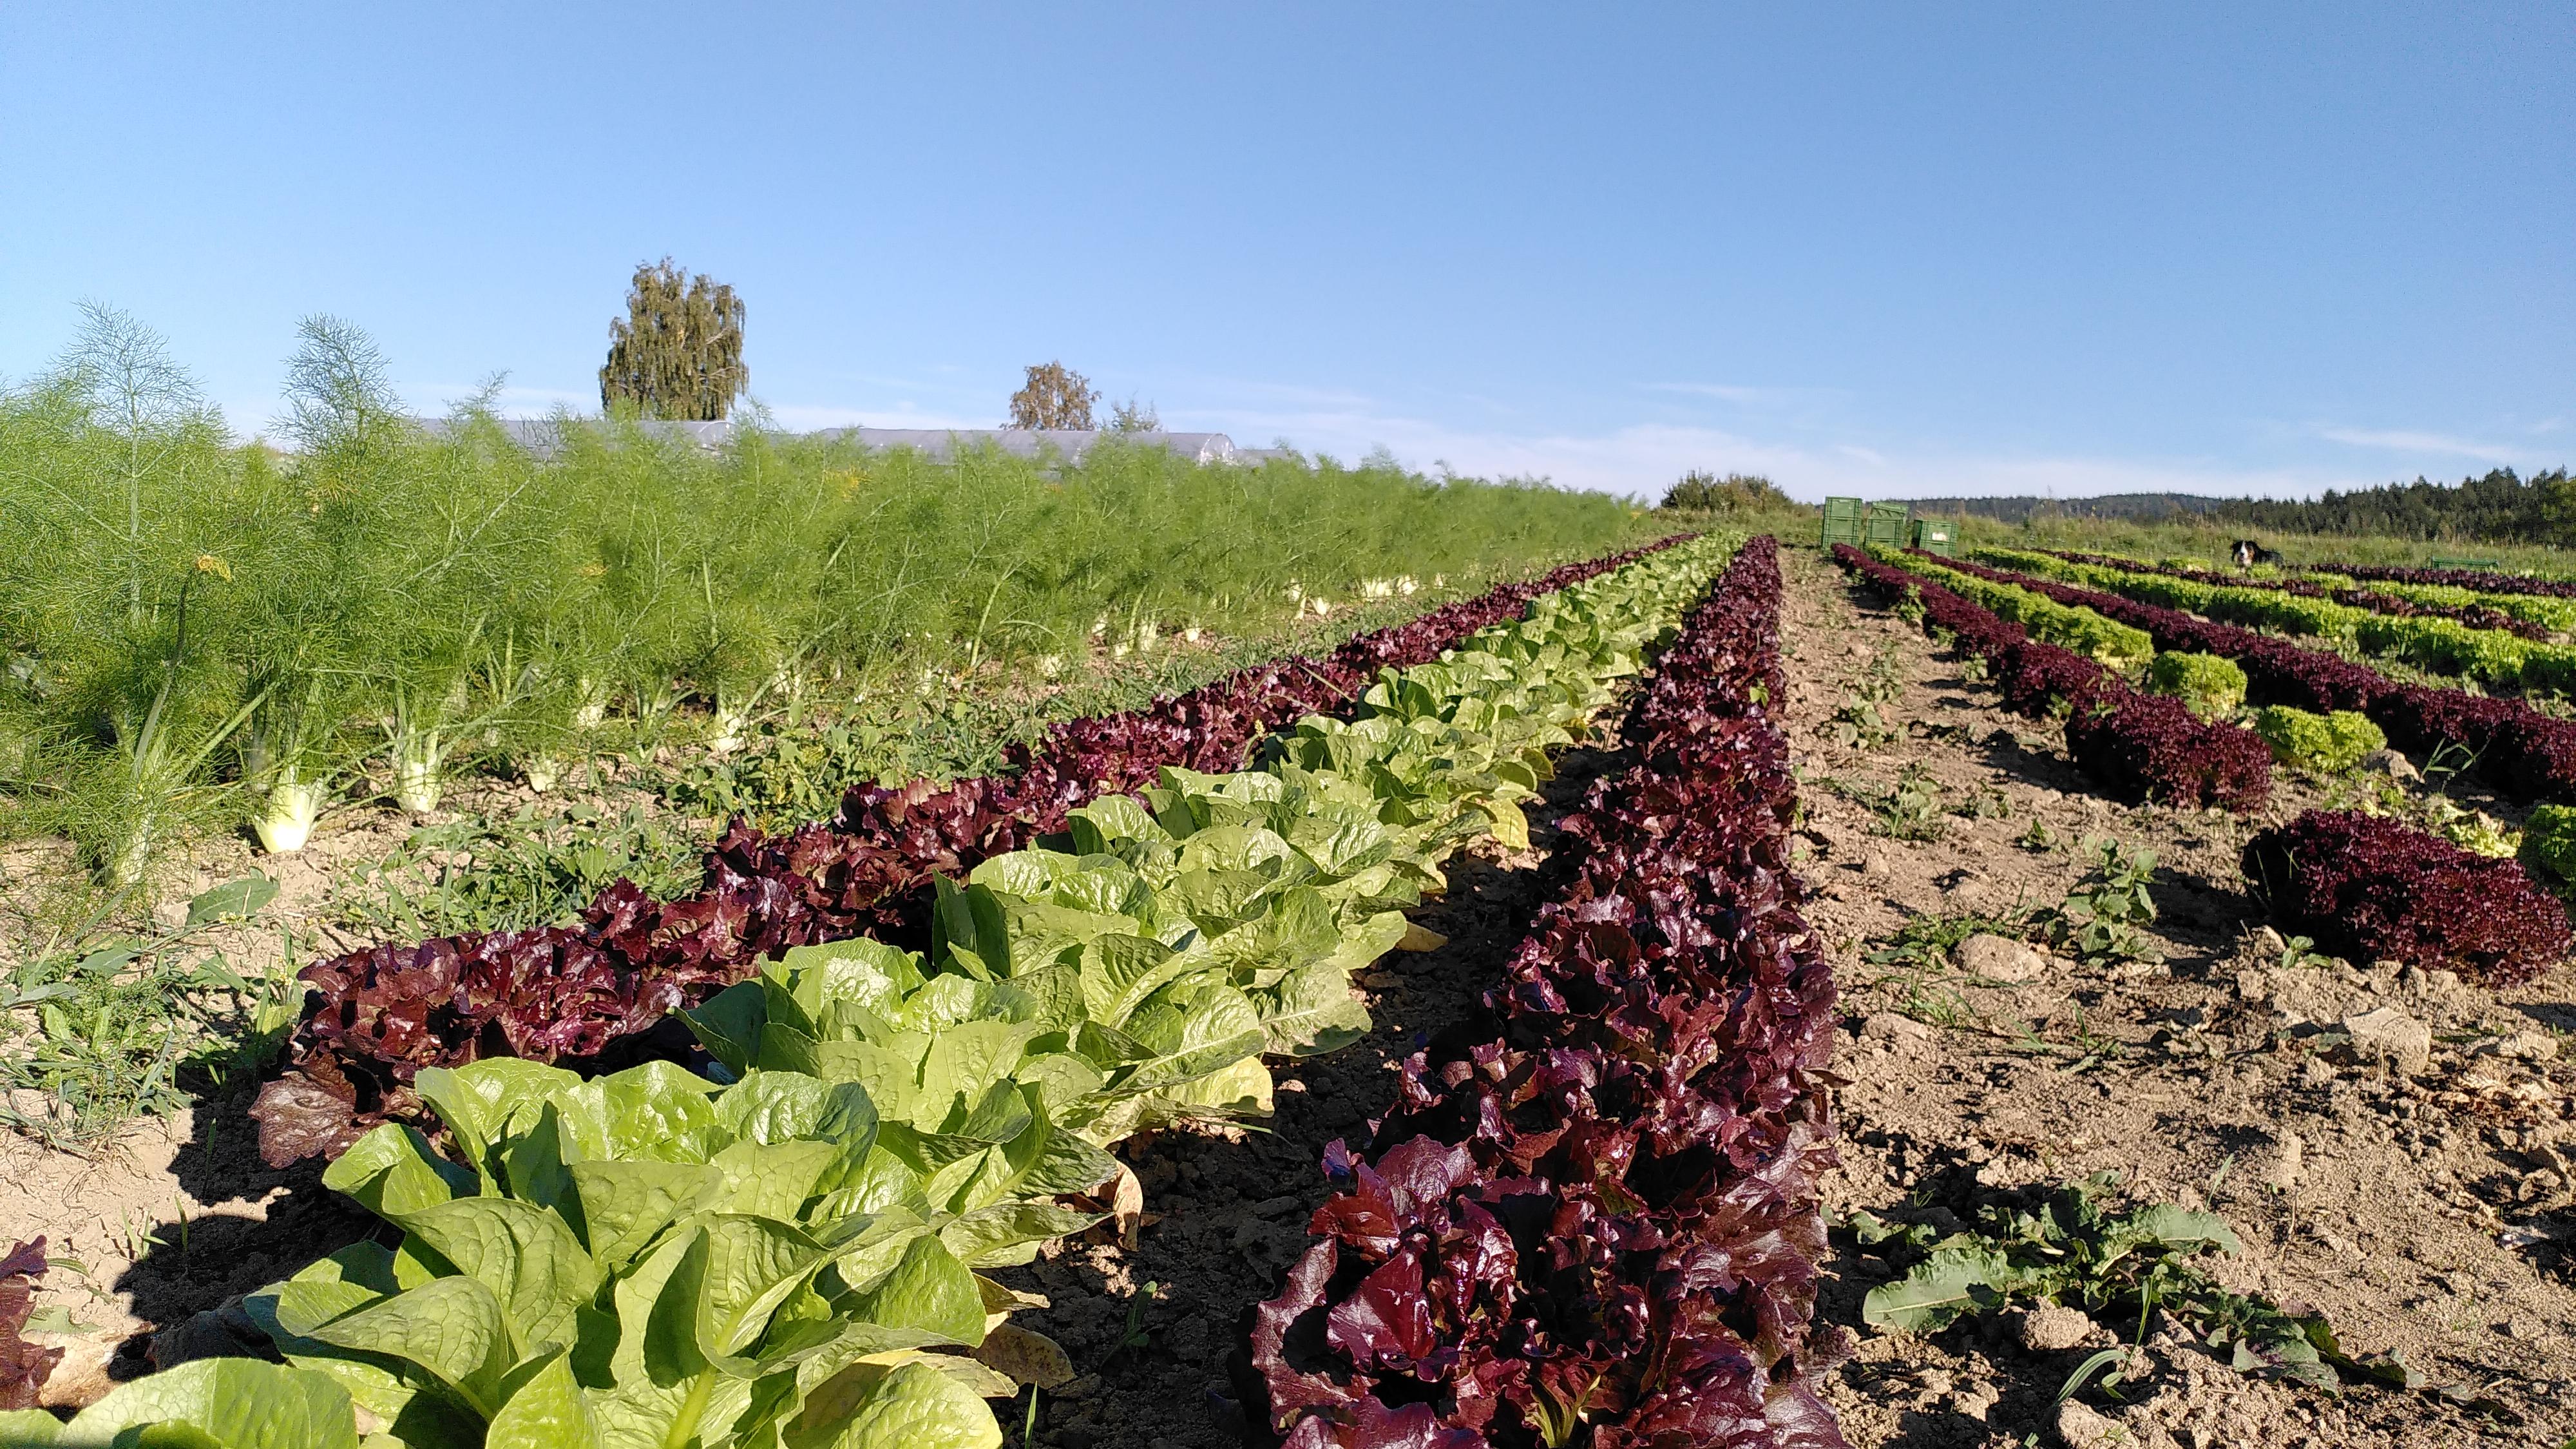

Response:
(0, 330), (1654, 1147)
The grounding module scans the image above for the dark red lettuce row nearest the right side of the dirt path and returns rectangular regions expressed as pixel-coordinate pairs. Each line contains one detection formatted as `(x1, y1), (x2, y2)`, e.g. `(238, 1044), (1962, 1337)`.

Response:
(1834, 544), (2272, 812)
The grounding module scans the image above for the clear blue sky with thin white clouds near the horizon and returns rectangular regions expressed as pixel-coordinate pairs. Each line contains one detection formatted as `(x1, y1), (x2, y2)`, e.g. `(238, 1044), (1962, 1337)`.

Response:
(0, 0), (2576, 497)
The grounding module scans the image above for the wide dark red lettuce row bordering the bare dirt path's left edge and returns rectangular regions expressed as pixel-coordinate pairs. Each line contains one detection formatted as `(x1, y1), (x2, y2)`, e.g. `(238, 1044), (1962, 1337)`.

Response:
(1237, 539), (1842, 1449)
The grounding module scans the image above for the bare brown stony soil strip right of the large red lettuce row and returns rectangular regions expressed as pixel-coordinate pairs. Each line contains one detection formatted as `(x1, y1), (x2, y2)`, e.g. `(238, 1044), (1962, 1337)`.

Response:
(1782, 549), (2576, 1449)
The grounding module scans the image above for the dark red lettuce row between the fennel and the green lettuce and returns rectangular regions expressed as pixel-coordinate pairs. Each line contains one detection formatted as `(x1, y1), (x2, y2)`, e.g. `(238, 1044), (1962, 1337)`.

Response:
(253, 539), (1677, 1166)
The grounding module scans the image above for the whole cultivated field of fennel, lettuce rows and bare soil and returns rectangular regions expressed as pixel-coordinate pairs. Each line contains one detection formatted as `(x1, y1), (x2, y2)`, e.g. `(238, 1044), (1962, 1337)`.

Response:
(0, 490), (2576, 1449)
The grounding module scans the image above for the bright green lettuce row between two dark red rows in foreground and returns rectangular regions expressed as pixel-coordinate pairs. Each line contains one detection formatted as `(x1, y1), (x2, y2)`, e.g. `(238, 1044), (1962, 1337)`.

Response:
(0, 539), (1728, 1449)
